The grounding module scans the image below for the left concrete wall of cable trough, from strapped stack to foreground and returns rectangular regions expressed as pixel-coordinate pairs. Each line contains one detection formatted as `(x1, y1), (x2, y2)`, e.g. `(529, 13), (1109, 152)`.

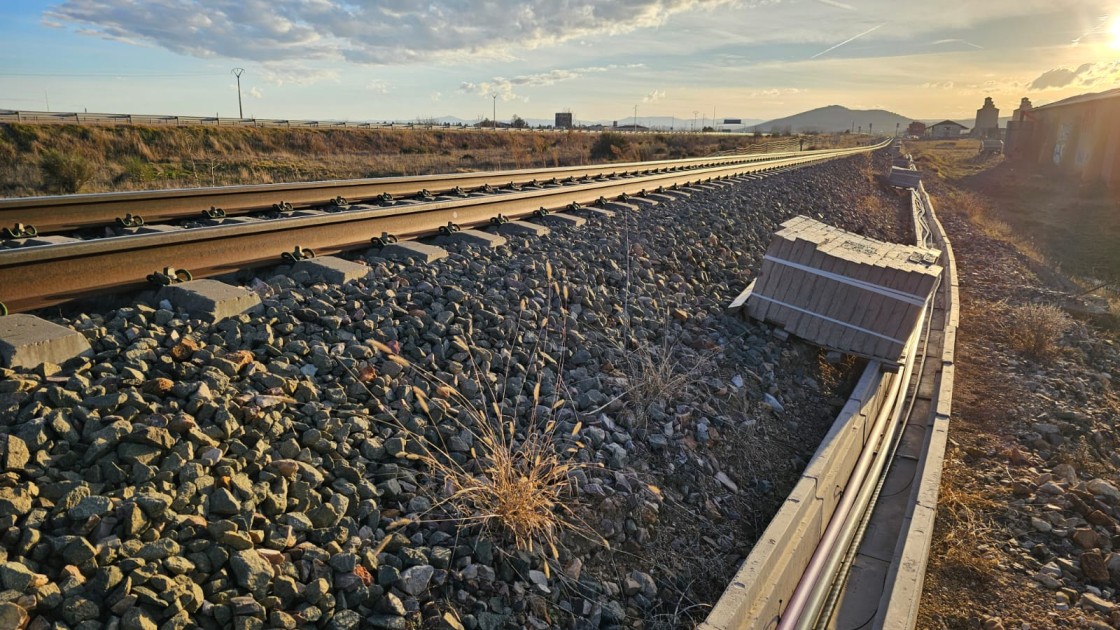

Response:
(697, 361), (898, 630)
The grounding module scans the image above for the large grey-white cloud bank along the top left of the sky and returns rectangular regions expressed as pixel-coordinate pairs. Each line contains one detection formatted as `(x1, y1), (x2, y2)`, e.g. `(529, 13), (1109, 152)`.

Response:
(43, 0), (755, 65)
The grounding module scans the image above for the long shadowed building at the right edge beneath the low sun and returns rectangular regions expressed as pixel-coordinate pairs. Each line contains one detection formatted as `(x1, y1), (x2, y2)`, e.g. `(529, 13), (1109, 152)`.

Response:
(1007, 87), (1120, 186)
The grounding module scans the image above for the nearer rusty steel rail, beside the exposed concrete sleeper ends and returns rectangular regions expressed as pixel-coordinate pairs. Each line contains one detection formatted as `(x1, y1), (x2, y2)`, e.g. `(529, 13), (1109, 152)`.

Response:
(0, 147), (874, 312)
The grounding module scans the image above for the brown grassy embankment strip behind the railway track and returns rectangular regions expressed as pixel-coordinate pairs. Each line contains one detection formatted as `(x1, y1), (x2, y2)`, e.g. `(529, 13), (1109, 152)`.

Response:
(0, 124), (860, 196)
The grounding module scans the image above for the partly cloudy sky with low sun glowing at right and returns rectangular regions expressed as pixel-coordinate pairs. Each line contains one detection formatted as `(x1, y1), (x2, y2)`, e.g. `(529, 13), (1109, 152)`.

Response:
(0, 0), (1120, 126)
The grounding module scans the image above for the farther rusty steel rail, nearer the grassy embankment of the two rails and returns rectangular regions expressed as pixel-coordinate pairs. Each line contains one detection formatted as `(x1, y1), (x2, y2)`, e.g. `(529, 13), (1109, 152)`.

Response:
(0, 149), (829, 234)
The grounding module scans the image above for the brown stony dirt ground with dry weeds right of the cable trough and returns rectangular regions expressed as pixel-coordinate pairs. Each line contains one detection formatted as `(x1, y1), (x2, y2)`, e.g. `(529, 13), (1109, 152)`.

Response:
(907, 140), (1120, 630)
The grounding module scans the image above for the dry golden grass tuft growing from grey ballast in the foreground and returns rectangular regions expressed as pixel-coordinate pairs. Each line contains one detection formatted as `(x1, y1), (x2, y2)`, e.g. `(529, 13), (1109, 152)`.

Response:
(352, 263), (609, 575)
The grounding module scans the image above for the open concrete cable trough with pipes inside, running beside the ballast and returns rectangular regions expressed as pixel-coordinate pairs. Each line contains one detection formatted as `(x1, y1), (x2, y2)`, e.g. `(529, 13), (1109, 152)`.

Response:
(701, 154), (959, 630)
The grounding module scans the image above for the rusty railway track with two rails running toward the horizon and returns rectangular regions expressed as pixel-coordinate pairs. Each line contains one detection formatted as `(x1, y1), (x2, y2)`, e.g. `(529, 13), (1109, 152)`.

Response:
(0, 148), (868, 312)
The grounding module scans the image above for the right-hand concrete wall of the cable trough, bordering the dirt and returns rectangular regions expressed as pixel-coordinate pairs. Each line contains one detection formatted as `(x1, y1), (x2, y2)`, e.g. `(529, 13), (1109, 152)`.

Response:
(872, 179), (960, 628)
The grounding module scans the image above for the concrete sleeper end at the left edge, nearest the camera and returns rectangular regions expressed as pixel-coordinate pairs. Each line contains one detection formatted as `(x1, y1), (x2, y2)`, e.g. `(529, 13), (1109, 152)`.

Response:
(0, 314), (93, 368)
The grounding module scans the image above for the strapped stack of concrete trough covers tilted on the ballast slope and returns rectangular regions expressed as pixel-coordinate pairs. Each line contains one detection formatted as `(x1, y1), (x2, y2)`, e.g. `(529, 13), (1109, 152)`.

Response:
(731, 216), (941, 365)
